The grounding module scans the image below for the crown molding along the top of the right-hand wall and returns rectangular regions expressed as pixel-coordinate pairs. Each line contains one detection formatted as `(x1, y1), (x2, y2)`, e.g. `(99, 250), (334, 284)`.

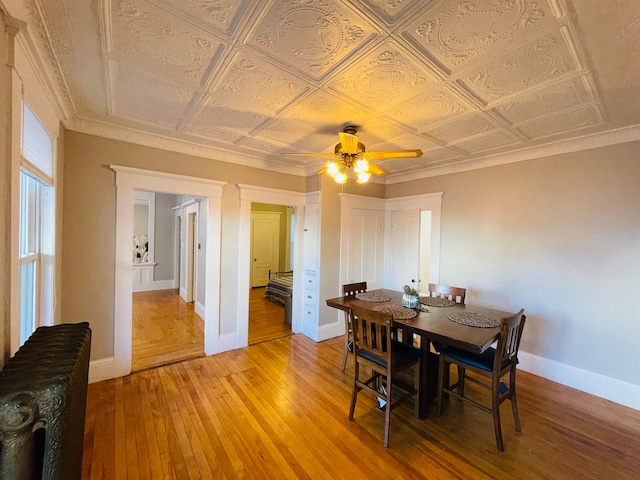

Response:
(384, 125), (640, 185)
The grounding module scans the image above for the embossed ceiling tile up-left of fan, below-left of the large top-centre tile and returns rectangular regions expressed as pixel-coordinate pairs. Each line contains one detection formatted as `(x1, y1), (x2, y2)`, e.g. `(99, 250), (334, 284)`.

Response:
(211, 53), (308, 116)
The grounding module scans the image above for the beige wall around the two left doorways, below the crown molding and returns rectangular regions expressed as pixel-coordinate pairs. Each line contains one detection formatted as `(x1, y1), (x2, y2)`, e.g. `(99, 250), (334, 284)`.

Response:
(62, 131), (305, 359)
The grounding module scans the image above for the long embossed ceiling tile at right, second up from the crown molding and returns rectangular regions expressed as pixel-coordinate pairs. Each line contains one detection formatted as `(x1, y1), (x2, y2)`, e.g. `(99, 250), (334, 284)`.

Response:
(495, 78), (593, 123)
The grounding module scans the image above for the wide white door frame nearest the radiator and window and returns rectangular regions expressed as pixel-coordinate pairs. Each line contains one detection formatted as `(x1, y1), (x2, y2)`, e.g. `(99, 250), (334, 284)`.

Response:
(109, 165), (226, 381)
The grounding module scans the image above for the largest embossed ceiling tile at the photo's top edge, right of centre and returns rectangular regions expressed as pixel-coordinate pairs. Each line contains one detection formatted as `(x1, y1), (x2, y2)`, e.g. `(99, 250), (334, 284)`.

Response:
(401, 0), (557, 72)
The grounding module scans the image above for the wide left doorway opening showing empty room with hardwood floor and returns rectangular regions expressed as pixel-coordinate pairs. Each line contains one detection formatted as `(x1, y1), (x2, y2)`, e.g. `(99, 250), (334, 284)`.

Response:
(131, 192), (205, 371)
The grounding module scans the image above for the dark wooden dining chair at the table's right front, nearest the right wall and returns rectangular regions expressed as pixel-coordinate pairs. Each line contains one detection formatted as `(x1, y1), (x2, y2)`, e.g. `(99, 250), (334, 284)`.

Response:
(437, 309), (526, 452)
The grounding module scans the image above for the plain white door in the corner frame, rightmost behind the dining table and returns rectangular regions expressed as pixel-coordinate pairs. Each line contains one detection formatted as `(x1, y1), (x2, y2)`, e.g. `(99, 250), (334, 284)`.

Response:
(387, 209), (420, 290)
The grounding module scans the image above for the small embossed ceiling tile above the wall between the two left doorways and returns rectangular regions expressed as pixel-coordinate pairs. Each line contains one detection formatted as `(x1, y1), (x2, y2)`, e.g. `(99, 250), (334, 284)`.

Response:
(187, 98), (271, 135)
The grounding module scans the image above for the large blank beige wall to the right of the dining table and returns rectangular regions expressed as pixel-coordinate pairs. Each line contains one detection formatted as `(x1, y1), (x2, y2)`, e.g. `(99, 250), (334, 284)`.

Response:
(387, 142), (640, 385)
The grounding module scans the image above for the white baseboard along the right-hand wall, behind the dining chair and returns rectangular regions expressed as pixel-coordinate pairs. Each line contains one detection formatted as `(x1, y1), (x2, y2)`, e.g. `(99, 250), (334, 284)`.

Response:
(518, 351), (640, 410)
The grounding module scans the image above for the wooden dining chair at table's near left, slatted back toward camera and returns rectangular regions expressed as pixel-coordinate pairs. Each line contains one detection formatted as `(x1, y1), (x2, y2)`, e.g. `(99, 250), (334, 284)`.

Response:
(349, 307), (422, 447)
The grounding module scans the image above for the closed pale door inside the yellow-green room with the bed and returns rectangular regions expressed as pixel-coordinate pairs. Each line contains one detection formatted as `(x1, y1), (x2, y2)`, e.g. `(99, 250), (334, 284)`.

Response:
(251, 212), (280, 287)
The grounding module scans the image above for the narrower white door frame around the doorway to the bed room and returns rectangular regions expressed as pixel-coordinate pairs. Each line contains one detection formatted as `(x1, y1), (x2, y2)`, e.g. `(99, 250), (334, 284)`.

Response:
(234, 184), (306, 350)
